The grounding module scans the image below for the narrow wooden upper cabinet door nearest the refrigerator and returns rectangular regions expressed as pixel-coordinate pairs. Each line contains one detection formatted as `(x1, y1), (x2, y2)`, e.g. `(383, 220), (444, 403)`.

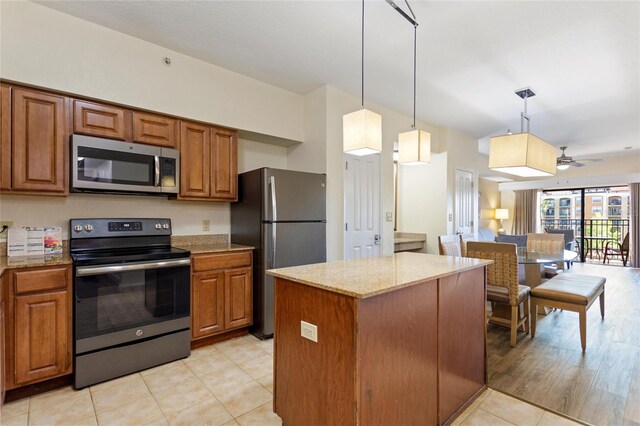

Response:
(211, 129), (238, 200)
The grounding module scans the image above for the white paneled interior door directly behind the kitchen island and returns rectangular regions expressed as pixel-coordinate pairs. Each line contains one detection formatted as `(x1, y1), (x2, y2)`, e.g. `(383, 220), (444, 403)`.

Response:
(344, 154), (382, 259)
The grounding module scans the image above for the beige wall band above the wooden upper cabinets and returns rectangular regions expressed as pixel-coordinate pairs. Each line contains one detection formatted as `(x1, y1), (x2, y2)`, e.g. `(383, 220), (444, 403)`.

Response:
(0, 1), (304, 141)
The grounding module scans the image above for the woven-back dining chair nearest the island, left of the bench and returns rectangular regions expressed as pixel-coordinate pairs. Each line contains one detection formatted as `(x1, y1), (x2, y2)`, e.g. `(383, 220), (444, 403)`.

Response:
(467, 241), (530, 348)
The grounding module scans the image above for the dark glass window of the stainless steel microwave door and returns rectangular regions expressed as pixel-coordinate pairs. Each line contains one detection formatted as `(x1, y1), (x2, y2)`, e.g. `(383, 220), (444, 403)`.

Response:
(78, 146), (155, 186)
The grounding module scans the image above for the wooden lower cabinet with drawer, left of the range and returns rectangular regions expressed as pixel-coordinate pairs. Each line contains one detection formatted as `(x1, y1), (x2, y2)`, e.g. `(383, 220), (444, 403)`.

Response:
(5, 266), (72, 389)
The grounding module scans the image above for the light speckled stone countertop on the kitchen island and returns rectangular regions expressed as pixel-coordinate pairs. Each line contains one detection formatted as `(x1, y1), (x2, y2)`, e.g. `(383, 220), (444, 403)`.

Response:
(267, 252), (492, 299)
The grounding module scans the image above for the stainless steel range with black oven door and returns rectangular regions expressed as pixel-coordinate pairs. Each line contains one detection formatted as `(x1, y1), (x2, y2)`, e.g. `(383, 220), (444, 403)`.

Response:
(69, 219), (190, 389)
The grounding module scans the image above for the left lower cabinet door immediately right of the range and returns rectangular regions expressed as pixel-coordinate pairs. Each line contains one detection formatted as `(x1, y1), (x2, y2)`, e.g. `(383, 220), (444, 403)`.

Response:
(191, 272), (224, 339)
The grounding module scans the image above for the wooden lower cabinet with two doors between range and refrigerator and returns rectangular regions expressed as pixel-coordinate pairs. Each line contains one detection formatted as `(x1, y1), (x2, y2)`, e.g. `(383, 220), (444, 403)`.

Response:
(191, 252), (253, 340)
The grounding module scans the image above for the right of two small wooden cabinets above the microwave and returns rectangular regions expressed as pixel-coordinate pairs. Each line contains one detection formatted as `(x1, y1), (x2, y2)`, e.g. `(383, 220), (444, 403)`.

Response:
(133, 112), (180, 148)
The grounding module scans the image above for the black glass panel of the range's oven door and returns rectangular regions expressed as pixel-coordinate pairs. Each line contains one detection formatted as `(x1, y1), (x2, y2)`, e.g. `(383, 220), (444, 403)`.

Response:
(75, 266), (190, 339)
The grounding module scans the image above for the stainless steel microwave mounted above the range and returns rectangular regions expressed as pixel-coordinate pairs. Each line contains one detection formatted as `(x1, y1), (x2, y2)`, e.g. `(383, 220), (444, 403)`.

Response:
(71, 135), (180, 195)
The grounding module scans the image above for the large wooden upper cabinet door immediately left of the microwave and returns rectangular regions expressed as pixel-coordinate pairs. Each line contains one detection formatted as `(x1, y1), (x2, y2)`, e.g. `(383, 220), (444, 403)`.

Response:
(11, 88), (69, 194)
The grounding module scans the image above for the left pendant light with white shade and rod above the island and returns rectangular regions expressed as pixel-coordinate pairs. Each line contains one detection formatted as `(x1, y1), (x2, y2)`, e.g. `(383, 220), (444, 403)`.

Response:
(342, 0), (382, 155)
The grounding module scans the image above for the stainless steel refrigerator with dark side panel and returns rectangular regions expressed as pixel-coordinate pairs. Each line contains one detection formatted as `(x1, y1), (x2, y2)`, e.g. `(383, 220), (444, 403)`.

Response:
(231, 168), (327, 339)
